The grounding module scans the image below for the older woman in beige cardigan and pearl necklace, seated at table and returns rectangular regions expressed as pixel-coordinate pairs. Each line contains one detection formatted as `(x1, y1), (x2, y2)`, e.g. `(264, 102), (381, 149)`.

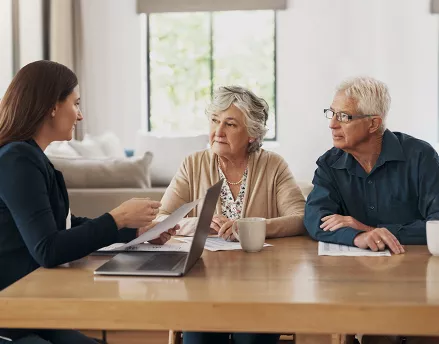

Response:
(158, 86), (305, 344)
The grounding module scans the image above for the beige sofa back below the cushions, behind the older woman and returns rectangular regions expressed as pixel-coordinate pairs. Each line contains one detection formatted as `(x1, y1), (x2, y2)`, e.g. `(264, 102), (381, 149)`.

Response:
(68, 182), (313, 218)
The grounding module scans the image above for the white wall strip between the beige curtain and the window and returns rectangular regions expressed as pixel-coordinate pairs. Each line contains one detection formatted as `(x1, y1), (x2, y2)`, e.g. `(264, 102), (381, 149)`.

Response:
(79, 0), (141, 147)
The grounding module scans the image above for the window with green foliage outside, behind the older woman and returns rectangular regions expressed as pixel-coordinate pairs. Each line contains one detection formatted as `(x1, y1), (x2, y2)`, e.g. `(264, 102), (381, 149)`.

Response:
(145, 11), (276, 139)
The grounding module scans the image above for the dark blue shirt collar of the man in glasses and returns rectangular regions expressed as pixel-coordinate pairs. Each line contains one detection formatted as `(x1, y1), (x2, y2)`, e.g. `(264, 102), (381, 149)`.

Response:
(331, 129), (406, 171)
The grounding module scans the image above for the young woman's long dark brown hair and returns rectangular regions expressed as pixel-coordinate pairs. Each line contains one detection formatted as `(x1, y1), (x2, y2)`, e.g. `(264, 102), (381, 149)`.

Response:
(0, 60), (78, 147)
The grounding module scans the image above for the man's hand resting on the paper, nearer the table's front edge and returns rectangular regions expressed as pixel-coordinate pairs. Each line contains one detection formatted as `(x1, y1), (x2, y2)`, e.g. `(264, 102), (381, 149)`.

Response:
(354, 228), (405, 254)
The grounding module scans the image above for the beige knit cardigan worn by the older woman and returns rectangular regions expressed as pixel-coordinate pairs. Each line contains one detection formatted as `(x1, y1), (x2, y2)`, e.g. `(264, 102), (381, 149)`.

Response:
(157, 149), (305, 238)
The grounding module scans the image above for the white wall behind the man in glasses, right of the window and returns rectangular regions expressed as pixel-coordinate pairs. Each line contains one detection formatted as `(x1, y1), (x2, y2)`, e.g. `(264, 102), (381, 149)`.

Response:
(278, 0), (439, 180)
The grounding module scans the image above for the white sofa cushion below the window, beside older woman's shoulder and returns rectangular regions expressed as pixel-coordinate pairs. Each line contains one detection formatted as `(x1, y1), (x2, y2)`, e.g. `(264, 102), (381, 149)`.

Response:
(135, 132), (209, 186)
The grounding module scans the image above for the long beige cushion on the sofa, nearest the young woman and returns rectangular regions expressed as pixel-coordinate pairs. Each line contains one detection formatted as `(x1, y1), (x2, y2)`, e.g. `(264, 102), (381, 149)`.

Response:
(48, 152), (152, 188)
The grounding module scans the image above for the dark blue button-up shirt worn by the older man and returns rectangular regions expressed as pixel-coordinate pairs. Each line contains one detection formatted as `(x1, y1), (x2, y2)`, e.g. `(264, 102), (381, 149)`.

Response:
(305, 130), (439, 246)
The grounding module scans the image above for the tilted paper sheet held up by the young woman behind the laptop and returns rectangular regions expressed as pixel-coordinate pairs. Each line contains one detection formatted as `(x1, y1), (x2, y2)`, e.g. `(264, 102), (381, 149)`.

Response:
(119, 198), (201, 250)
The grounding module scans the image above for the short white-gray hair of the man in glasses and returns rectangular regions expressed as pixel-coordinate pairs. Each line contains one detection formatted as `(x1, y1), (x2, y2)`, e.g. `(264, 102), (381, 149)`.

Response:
(337, 77), (391, 132)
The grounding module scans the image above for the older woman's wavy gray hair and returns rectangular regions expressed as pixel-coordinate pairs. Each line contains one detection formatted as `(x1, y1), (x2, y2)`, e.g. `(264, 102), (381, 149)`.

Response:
(206, 86), (268, 153)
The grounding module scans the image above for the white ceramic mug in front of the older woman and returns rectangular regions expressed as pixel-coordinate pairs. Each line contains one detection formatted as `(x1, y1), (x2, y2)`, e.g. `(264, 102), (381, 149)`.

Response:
(232, 217), (267, 252)
